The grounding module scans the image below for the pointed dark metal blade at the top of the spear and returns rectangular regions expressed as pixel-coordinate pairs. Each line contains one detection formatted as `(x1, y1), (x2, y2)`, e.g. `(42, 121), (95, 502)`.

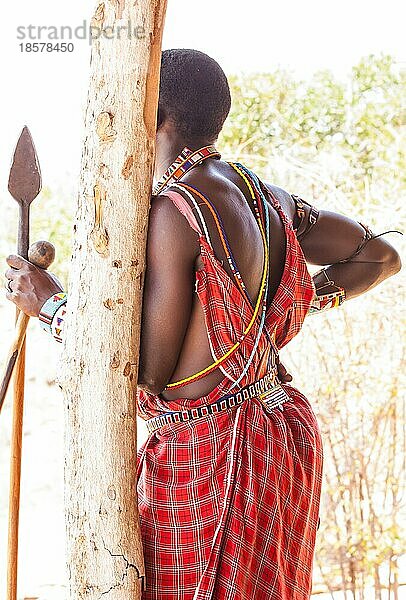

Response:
(8, 127), (42, 206)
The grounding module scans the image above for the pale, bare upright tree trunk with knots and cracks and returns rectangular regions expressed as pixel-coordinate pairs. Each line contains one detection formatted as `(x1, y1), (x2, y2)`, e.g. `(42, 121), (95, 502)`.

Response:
(59, 0), (166, 600)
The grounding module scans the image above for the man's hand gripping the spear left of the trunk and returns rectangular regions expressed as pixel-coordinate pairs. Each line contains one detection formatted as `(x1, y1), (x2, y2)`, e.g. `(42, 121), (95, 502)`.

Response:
(5, 254), (63, 317)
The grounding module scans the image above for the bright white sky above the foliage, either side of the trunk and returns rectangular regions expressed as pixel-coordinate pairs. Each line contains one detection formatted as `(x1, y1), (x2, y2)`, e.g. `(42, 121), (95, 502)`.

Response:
(0, 0), (406, 195)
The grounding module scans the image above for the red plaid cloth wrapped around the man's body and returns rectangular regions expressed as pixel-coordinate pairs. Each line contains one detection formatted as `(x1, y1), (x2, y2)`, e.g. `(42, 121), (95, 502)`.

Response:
(137, 180), (322, 600)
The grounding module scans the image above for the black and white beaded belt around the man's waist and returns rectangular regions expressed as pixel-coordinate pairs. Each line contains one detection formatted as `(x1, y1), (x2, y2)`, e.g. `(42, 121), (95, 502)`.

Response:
(146, 372), (289, 433)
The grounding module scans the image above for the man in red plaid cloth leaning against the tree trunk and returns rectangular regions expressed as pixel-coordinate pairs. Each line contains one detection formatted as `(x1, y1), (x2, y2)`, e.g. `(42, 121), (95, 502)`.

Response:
(6, 50), (400, 600)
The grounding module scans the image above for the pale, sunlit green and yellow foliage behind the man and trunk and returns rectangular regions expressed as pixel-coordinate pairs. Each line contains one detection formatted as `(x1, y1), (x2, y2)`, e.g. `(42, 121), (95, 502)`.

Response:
(0, 56), (406, 600)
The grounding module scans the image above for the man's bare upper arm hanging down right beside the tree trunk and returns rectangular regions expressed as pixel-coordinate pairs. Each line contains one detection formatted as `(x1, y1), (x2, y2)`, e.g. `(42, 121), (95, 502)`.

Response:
(138, 196), (200, 394)
